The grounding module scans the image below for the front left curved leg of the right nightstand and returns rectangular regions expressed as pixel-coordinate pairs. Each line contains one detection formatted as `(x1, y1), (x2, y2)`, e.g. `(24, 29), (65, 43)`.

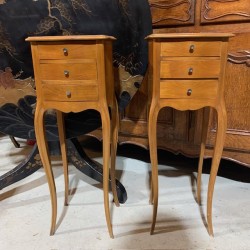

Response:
(148, 106), (159, 234)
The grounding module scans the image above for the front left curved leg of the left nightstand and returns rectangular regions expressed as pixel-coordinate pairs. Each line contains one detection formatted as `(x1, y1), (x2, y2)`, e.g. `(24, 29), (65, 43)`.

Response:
(35, 103), (57, 235)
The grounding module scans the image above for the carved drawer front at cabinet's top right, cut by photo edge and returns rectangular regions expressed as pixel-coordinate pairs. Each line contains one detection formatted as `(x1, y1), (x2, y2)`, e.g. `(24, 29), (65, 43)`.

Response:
(201, 0), (250, 24)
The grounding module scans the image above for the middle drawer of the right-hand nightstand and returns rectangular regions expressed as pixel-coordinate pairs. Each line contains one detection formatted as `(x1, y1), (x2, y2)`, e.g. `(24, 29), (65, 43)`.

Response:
(160, 59), (220, 78)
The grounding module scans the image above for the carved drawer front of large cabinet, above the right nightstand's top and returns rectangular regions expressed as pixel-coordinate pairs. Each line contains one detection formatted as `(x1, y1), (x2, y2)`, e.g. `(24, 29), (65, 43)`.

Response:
(149, 0), (195, 26)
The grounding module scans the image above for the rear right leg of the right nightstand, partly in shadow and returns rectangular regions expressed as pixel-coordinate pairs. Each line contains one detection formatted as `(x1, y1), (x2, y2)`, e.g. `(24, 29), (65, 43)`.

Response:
(197, 107), (210, 205)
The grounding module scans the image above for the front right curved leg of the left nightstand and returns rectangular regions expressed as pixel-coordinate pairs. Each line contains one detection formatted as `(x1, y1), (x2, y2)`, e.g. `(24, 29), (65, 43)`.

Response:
(100, 108), (114, 238)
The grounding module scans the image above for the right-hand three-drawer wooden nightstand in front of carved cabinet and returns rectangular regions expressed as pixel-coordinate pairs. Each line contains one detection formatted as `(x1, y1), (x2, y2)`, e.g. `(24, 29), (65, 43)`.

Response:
(147, 33), (233, 235)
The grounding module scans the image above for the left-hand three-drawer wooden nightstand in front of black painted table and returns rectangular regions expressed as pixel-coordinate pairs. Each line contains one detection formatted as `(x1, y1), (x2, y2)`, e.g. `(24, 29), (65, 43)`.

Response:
(26, 35), (119, 238)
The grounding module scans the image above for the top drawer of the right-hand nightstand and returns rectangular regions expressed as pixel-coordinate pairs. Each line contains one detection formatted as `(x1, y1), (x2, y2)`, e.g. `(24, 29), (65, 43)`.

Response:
(161, 41), (221, 57)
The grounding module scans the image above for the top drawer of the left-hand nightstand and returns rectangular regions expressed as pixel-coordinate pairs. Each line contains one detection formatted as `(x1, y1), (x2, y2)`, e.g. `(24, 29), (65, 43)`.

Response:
(37, 42), (96, 60)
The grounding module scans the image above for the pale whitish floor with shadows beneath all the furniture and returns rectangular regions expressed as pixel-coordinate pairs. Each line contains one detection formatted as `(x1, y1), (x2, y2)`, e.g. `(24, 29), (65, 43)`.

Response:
(0, 136), (250, 250)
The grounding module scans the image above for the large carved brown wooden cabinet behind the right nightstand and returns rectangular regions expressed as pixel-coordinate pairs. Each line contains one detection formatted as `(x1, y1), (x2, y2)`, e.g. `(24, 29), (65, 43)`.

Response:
(92, 0), (250, 166)
